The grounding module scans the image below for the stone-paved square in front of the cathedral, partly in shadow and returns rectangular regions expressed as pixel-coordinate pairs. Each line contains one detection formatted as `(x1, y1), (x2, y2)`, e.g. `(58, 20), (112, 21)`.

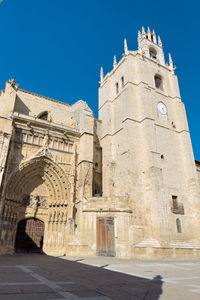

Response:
(0, 254), (200, 300)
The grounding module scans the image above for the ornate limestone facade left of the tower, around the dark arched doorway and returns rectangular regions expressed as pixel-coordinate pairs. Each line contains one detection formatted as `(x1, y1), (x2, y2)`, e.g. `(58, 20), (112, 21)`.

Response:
(0, 82), (97, 254)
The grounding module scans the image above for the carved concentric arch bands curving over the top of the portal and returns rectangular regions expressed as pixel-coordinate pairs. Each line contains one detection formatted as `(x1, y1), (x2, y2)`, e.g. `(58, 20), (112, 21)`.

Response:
(6, 156), (70, 204)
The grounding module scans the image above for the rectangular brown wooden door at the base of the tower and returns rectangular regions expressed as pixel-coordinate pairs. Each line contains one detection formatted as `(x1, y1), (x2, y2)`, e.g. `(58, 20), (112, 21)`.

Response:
(97, 217), (115, 256)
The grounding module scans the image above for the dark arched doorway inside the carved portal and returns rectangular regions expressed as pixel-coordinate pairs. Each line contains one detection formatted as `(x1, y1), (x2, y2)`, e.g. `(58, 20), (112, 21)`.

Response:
(15, 218), (44, 253)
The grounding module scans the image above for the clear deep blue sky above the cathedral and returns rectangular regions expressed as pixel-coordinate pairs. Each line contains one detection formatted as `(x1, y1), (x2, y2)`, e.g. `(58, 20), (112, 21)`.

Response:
(0, 0), (200, 160)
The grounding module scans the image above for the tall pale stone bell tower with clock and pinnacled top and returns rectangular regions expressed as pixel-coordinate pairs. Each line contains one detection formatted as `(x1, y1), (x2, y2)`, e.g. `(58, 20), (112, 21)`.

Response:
(99, 28), (200, 257)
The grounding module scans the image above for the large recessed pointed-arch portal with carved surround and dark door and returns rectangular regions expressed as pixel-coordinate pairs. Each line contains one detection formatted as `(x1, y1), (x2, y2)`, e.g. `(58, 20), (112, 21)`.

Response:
(1, 155), (70, 252)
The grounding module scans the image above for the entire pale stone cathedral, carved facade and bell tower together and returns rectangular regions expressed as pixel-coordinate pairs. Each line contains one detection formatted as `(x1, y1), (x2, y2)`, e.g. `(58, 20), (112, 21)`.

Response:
(0, 27), (200, 259)
